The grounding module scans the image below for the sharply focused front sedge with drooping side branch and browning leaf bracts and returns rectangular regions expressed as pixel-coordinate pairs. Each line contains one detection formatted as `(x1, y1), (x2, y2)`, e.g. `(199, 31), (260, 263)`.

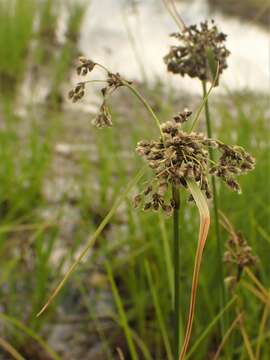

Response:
(38, 50), (255, 359)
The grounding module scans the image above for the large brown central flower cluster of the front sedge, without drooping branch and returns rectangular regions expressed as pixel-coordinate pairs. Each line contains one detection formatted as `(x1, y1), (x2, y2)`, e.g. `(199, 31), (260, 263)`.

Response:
(135, 110), (255, 214)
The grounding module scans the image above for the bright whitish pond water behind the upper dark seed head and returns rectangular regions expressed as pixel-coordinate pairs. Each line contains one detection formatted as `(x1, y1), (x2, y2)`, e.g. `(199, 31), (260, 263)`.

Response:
(79, 0), (269, 93)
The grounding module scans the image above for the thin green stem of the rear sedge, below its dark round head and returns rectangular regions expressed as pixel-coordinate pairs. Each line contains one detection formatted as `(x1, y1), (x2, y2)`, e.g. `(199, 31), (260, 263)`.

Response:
(202, 81), (226, 337)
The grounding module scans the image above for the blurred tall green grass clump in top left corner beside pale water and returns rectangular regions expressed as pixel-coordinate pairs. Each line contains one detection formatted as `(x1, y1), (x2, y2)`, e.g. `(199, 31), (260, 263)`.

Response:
(0, 0), (86, 103)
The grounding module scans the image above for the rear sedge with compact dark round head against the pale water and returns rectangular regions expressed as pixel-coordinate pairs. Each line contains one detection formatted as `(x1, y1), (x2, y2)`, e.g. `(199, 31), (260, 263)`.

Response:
(164, 0), (230, 352)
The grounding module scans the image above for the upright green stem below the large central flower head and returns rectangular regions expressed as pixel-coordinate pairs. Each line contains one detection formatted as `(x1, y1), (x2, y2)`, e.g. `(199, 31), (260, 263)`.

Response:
(172, 186), (180, 360)
